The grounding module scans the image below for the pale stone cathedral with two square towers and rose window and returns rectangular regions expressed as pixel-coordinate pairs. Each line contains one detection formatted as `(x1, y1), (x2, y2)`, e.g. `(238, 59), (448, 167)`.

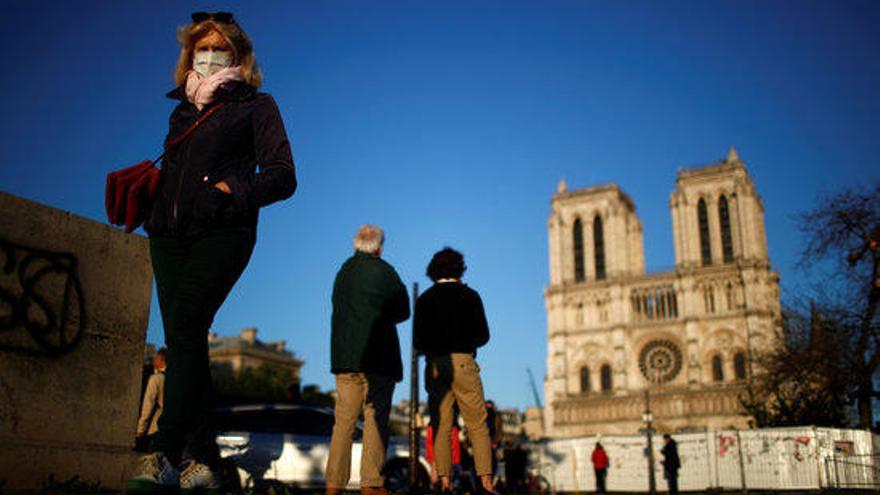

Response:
(544, 148), (780, 437)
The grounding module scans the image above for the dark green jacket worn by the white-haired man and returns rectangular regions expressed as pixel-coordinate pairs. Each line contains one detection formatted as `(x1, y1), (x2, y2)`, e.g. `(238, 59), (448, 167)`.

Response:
(330, 252), (409, 381)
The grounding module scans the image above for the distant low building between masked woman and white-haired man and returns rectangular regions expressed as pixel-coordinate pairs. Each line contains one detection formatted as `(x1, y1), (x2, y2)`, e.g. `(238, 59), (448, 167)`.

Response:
(208, 328), (303, 382)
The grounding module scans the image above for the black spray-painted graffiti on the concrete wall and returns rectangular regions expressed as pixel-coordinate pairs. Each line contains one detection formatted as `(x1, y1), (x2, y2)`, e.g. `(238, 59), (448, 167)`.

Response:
(0, 239), (86, 356)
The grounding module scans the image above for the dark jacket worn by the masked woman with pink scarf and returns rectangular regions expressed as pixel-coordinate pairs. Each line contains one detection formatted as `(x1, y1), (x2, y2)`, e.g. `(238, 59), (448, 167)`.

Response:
(144, 83), (296, 237)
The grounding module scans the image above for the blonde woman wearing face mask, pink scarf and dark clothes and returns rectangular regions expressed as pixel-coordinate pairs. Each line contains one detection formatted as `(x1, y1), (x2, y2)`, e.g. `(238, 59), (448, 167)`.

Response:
(126, 12), (296, 493)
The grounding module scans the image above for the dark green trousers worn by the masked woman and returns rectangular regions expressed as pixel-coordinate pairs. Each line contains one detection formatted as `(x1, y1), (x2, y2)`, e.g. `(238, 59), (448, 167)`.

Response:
(150, 230), (256, 466)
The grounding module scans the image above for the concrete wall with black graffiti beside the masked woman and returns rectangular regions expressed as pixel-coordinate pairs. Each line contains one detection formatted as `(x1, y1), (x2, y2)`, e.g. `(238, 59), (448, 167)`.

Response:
(0, 192), (152, 490)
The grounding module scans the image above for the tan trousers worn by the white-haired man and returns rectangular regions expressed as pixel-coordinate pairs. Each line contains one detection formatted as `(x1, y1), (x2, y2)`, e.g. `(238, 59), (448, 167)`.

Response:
(327, 373), (394, 489)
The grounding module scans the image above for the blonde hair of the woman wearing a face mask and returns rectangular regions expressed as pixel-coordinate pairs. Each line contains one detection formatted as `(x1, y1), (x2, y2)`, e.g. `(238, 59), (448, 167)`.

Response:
(174, 19), (263, 88)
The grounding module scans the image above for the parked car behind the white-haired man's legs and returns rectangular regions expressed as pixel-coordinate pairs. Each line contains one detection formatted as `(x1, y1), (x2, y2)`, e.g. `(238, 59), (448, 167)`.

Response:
(215, 404), (430, 492)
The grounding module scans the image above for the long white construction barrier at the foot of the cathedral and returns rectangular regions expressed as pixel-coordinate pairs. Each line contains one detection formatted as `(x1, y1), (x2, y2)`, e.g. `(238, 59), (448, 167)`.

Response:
(530, 427), (880, 492)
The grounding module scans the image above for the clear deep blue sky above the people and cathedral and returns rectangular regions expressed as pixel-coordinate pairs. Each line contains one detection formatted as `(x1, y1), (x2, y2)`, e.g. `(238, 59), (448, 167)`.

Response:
(0, 0), (880, 407)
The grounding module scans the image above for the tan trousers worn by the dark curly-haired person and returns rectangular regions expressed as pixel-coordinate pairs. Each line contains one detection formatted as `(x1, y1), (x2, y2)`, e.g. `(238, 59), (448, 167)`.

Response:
(425, 354), (492, 476)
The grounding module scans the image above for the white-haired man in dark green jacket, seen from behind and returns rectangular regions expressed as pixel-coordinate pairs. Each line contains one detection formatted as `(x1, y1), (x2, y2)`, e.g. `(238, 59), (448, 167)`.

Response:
(327, 225), (409, 495)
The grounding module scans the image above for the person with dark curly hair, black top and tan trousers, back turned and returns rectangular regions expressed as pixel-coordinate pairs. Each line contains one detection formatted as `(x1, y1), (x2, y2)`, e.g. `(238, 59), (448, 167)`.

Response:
(413, 247), (493, 492)
